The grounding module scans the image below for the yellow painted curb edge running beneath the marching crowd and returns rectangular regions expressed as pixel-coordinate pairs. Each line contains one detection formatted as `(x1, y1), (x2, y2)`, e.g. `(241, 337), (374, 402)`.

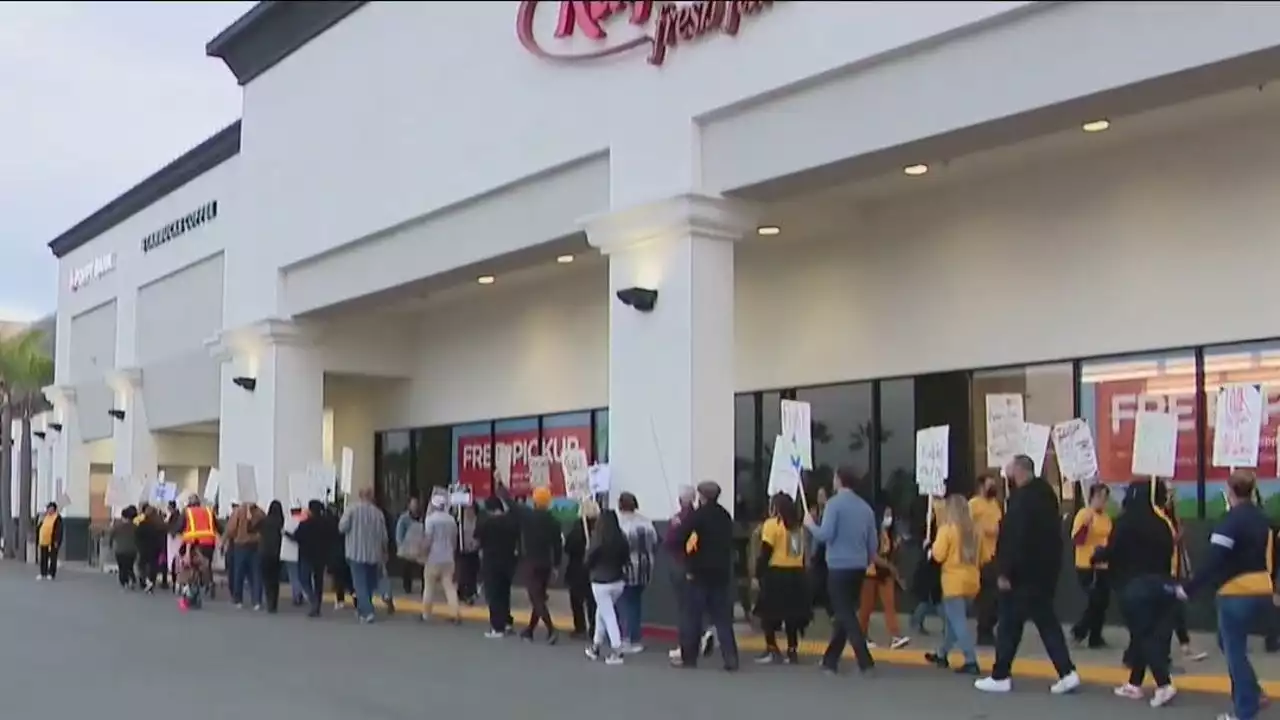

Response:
(325, 594), (1264, 697)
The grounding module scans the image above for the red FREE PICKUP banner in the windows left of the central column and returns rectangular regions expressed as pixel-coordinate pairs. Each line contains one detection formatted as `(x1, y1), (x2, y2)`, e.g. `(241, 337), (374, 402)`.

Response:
(457, 425), (591, 497)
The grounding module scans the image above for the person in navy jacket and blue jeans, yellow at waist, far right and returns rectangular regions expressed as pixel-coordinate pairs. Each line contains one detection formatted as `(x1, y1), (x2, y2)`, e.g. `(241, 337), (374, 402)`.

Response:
(1178, 470), (1280, 720)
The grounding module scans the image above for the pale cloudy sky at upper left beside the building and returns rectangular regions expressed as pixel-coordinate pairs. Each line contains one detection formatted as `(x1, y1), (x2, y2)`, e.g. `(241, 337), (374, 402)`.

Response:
(0, 1), (253, 320)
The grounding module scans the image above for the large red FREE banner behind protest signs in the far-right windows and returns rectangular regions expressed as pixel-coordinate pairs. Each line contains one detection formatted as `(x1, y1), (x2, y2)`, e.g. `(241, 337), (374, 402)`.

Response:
(1087, 378), (1280, 482)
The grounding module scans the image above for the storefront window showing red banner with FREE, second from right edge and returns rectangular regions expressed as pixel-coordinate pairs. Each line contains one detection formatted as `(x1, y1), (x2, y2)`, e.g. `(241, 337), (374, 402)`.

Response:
(1080, 350), (1201, 518)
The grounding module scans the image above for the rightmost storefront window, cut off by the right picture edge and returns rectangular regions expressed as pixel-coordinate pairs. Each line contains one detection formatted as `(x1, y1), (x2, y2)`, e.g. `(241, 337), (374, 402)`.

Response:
(1204, 341), (1280, 518)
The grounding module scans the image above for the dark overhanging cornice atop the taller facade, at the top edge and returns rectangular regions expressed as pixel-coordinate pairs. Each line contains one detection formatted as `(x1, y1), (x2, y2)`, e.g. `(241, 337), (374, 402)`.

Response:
(205, 0), (365, 85)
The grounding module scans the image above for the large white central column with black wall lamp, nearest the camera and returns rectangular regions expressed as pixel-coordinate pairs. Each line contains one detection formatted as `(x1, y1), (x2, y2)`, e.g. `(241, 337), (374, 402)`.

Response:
(586, 195), (755, 519)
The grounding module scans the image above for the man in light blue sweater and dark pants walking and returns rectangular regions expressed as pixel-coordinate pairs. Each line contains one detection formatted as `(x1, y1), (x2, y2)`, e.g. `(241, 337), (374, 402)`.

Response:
(805, 469), (879, 674)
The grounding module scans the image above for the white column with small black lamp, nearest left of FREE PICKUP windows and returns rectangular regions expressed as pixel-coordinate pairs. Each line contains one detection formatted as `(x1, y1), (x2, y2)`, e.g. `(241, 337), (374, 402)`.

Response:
(209, 319), (324, 505)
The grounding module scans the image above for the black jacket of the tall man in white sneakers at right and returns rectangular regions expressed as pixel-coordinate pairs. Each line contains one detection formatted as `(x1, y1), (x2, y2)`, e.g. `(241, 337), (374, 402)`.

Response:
(996, 478), (1064, 596)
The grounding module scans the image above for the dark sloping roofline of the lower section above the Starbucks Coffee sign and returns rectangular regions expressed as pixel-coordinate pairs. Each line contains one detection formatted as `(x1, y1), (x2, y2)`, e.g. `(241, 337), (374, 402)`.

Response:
(49, 120), (241, 258)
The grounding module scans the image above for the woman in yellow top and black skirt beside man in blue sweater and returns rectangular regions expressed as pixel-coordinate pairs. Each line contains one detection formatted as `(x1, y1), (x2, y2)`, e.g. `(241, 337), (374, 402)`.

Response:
(755, 493), (813, 665)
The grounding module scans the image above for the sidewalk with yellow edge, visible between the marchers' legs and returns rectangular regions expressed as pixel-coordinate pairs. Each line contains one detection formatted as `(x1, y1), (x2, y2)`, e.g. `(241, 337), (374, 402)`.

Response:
(49, 564), (1280, 697)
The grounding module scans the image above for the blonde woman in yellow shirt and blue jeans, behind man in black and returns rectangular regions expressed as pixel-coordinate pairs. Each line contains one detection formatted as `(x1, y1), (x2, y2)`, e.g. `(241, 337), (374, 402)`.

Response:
(924, 495), (982, 675)
